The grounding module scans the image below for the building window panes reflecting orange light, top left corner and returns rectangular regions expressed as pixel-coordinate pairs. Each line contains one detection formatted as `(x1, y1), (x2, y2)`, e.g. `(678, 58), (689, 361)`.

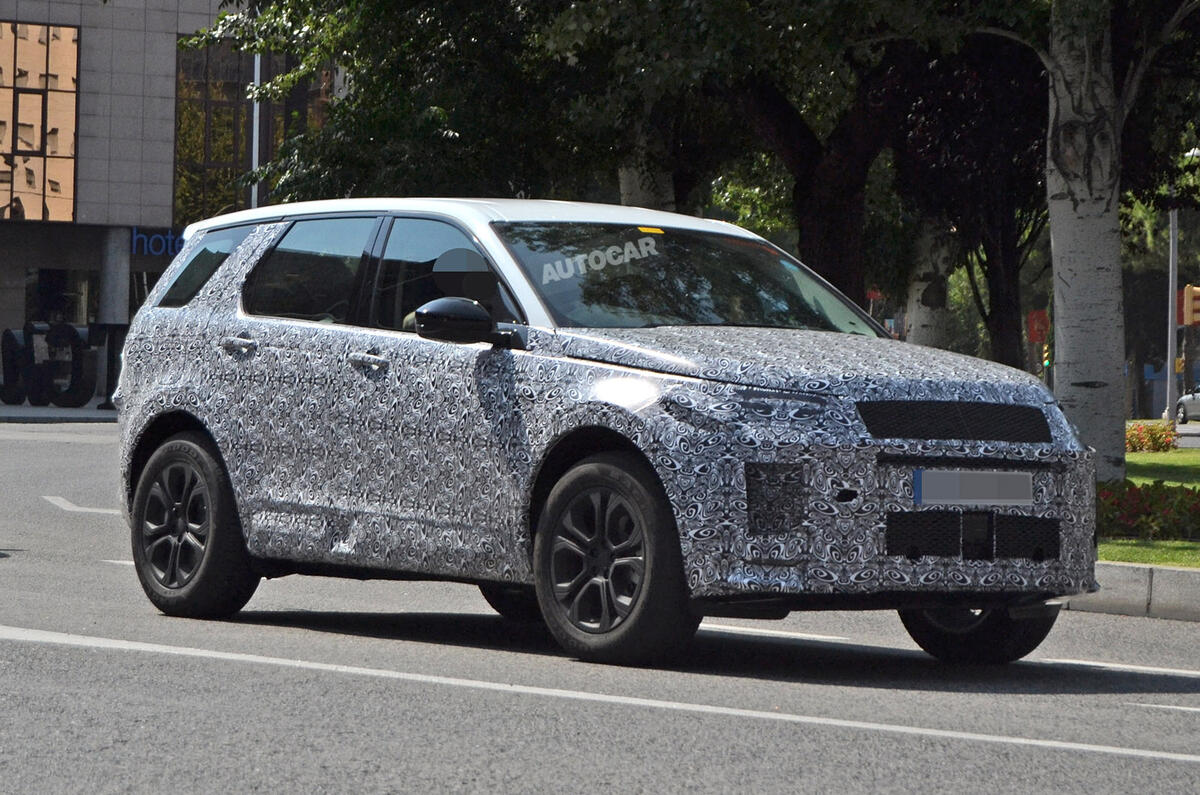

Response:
(0, 22), (79, 221)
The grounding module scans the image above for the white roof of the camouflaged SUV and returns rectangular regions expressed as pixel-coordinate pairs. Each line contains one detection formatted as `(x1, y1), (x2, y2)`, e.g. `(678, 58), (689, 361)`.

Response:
(184, 198), (757, 238)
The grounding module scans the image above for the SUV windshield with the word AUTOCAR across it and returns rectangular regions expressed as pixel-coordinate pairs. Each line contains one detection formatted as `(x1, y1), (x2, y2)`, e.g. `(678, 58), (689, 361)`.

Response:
(493, 222), (878, 336)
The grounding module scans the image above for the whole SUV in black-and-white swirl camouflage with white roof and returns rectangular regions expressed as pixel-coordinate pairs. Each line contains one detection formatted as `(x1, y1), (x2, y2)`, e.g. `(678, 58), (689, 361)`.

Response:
(118, 199), (1094, 662)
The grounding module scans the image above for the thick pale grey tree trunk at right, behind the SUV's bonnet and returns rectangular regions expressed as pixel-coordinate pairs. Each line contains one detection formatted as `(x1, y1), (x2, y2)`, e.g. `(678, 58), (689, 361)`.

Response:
(1046, 0), (1124, 480)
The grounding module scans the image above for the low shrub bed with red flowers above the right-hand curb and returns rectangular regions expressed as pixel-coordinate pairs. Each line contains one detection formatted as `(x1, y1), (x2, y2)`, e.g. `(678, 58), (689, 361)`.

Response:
(1096, 480), (1200, 540)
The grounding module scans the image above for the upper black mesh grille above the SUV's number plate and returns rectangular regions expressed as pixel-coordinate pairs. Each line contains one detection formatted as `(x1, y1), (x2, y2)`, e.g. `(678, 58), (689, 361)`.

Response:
(858, 400), (1050, 442)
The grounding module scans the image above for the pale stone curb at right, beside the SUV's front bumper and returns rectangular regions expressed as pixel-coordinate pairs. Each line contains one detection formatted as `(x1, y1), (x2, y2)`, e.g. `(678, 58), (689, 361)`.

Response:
(1062, 563), (1200, 621)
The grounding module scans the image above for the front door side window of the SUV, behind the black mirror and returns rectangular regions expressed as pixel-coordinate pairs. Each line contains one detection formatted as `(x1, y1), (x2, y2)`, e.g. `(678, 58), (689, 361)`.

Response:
(374, 219), (520, 331)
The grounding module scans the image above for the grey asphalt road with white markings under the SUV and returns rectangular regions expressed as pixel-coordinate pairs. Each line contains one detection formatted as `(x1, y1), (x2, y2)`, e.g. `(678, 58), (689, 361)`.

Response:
(0, 424), (1200, 793)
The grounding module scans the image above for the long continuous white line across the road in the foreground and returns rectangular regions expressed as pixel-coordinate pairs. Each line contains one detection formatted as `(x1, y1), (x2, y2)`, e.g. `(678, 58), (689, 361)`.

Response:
(0, 624), (1200, 764)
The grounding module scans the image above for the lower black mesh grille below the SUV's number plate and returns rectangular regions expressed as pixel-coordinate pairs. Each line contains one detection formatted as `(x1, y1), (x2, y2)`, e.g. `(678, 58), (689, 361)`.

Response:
(884, 510), (1060, 561)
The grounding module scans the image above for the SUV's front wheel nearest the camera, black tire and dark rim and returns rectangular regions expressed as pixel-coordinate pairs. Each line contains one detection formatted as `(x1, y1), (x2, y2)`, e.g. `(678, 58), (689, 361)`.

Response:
(534, 453), (700, 664)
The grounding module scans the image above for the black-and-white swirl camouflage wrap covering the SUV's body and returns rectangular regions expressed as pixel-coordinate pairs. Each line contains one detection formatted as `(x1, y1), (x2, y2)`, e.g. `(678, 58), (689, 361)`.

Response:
(119, 200), (1094, 610)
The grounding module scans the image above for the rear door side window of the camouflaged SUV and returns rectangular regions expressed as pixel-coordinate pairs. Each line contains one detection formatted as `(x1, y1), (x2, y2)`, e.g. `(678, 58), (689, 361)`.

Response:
(242, 217), (376, 323)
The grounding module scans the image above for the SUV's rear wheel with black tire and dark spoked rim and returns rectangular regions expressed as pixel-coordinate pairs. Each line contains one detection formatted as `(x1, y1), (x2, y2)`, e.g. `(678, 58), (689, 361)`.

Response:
(130, 432), (259, 618)
